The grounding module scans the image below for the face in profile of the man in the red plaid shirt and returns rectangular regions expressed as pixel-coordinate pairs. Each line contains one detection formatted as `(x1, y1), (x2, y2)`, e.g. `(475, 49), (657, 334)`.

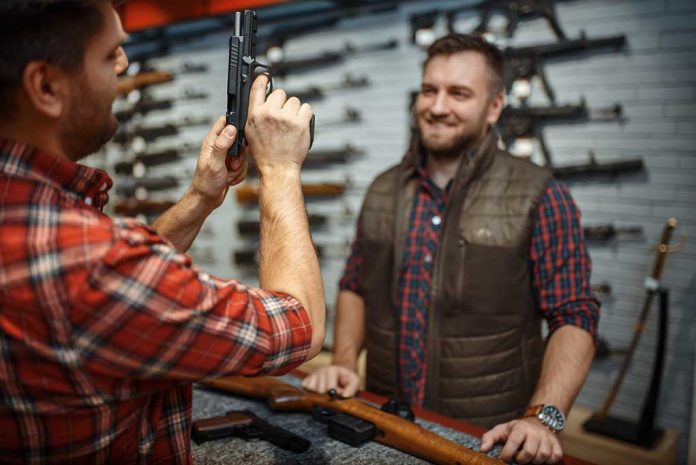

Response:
(60, 2), (128, 160)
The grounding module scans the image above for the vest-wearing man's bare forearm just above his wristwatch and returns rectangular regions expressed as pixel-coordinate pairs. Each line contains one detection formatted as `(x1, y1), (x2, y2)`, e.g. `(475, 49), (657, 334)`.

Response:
(529, 325), (594, 414)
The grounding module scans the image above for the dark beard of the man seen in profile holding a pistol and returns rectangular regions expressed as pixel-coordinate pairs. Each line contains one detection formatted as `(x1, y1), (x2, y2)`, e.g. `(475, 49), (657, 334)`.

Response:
(60, 77), (118, 161)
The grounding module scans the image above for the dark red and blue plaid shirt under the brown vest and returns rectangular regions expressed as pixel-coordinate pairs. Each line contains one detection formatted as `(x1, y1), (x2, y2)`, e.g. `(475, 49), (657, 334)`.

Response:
(339, 161), (599, 405)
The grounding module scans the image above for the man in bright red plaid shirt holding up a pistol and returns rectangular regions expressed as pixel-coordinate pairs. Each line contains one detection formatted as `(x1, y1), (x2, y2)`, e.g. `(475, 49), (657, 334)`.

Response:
(0, 0), (325, 464)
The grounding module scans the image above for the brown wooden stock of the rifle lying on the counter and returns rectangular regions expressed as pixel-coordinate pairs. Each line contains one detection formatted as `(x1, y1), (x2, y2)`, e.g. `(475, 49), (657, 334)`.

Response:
(202, 377), (503, 465)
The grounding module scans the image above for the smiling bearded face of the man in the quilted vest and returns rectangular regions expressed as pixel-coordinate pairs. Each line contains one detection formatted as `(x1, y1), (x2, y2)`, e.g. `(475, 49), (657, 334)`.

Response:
(414, 51), (503, 159)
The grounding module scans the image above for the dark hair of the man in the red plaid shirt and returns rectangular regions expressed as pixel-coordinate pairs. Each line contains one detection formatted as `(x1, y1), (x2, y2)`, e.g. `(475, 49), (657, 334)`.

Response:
(0, 0), (107, 118)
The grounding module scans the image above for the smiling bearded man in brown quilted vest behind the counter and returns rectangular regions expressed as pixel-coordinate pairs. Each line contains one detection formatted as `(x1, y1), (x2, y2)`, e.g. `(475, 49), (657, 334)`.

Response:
(304, 34), (599, 463)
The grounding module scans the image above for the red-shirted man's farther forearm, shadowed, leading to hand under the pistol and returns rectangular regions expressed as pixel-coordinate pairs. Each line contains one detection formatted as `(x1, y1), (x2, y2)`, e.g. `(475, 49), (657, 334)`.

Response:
(152, 191), (213, 253)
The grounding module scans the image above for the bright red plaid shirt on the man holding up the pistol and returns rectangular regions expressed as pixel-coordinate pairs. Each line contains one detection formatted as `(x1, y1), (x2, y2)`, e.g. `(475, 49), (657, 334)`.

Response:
(0, 140), (311, 464)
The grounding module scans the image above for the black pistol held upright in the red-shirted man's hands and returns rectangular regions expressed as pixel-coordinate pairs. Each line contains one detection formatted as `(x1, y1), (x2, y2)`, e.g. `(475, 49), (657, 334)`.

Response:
(226, 10), (314, 157)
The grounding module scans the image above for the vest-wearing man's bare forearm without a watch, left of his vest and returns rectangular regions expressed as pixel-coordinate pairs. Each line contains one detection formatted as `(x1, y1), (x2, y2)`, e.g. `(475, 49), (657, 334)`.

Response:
(333, 291), (365, 371)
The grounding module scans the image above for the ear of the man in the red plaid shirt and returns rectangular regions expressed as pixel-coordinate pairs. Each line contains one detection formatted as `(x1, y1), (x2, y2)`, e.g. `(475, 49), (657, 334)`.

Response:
(22, 61), (70, 118)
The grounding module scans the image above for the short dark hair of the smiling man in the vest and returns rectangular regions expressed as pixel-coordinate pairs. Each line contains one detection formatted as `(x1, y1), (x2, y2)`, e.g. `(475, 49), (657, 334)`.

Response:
(423, 33), (505, 97)
